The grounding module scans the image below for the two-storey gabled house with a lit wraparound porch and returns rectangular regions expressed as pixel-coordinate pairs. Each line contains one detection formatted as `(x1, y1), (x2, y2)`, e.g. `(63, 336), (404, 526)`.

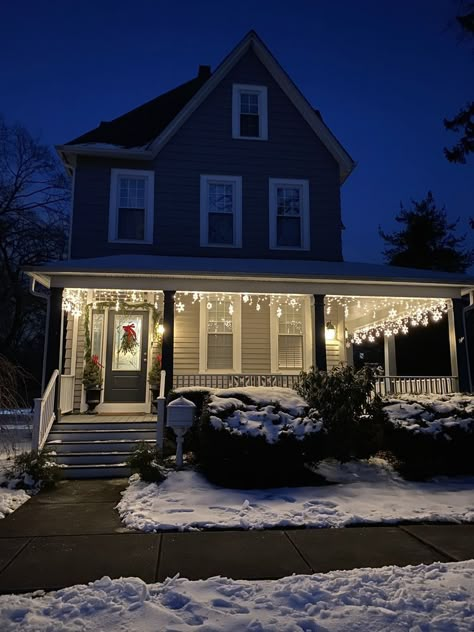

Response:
(28, 31), (474, 474)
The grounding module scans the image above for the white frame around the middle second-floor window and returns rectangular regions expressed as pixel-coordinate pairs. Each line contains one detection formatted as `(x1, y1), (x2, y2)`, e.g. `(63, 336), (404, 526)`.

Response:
(200, 175), (242, 248)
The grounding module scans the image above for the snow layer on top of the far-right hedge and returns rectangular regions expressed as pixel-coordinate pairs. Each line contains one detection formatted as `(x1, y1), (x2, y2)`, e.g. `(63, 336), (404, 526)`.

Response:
(384, 393), (474, 435)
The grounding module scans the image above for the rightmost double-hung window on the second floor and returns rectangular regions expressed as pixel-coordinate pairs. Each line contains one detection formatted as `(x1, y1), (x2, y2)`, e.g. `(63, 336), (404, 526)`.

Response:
(269, 178), (310, 250)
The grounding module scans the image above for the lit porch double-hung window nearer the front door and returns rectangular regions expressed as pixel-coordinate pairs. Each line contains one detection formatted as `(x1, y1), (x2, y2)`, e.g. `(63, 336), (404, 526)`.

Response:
(199, 296), (241, 373)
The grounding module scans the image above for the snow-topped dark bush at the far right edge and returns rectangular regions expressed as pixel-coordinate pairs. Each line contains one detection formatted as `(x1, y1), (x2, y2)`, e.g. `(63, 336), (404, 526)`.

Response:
(384, 394), (474, 480)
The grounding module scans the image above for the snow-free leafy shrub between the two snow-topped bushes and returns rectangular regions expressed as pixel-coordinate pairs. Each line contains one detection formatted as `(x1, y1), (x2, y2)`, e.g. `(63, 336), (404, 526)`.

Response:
(295, 364), (385, 461)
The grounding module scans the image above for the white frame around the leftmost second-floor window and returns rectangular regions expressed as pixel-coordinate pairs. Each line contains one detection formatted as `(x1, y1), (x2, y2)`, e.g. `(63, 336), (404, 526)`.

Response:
(109, 169), (155, 244)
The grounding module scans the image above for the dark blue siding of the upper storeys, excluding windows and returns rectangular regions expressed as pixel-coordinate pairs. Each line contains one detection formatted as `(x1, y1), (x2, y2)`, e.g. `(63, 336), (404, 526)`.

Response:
(71, 51), (342, 261)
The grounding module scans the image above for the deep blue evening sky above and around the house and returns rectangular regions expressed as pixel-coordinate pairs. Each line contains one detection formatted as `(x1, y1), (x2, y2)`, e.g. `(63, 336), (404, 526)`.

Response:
(0, 0), (474, 262)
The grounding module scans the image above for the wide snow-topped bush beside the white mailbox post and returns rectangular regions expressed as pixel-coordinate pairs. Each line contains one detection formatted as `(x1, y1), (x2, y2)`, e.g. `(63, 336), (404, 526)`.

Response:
(196, 387), (324, 488)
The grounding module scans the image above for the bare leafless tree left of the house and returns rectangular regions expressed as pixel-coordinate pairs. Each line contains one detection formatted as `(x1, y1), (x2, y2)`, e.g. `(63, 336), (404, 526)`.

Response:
(0, 117), (70, 357)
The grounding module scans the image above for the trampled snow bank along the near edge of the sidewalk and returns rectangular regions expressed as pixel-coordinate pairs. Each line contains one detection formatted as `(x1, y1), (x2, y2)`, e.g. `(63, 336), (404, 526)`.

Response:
(0, 560), (474, 632)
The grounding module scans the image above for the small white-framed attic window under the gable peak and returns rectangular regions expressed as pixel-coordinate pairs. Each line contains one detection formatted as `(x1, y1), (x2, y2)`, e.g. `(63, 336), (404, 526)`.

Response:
(232, 84), (268, 140)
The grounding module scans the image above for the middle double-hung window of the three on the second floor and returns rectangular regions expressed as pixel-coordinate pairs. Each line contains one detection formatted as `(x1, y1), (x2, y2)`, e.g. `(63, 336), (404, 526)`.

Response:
(201, 176), (242, 248)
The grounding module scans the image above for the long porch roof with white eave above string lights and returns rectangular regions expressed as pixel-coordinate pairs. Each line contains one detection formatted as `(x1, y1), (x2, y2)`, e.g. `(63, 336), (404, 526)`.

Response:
(24, 255), (474, 297)
